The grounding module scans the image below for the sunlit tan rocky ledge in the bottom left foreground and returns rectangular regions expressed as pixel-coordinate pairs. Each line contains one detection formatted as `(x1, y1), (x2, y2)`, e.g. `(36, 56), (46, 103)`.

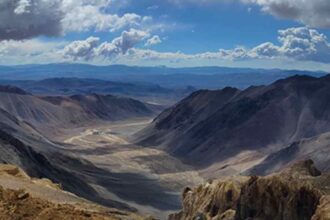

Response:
(0, 164), (151, 220)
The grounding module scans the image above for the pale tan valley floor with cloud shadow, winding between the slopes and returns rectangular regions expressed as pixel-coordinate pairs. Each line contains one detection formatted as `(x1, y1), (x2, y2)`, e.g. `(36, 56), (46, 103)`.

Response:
(56, 118), (204, 219)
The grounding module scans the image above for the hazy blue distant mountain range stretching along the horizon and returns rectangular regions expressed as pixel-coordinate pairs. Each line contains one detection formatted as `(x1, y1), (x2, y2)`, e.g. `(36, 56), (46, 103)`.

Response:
(0, 63), (326, 89)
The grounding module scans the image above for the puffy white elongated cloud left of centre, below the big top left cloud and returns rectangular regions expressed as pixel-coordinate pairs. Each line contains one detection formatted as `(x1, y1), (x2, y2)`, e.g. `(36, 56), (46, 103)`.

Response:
(62, 29), (150, 60)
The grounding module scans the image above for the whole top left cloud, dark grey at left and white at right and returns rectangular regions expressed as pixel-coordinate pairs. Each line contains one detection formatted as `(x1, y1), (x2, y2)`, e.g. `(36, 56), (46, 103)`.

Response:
(0, 0), (152, 41)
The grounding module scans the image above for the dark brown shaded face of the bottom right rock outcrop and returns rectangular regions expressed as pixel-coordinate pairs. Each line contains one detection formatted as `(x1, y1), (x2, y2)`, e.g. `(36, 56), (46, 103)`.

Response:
(236, 177), (321, 220)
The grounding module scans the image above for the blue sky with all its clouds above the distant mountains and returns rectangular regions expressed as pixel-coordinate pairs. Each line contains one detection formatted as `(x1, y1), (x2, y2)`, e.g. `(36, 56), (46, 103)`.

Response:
(0, 0), (330, 71)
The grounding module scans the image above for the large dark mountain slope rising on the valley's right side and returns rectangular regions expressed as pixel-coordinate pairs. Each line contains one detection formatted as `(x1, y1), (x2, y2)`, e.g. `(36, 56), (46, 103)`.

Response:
(136, 76), (330, 171)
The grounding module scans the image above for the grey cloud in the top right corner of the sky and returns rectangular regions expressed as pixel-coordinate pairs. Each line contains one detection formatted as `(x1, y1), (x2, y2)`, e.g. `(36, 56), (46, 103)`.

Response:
(242, 0), (330, 28)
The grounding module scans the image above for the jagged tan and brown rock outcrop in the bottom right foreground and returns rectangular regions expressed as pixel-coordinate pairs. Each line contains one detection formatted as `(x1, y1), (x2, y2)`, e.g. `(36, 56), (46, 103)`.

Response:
(169, 160), (330, 220)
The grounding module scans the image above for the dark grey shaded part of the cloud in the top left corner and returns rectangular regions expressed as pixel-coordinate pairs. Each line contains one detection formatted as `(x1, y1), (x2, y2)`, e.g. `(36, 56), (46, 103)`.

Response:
(0, 0), (63, 41)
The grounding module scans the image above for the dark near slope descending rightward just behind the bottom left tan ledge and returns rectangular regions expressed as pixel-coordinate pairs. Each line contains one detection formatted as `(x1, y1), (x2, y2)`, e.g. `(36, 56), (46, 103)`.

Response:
(0, 110), (138, 209)
